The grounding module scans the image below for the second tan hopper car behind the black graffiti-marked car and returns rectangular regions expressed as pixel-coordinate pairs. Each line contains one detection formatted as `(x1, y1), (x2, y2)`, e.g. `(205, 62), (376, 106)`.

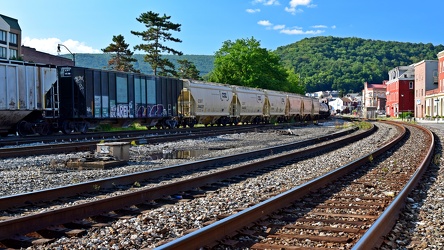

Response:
(232, 86), (265, 122)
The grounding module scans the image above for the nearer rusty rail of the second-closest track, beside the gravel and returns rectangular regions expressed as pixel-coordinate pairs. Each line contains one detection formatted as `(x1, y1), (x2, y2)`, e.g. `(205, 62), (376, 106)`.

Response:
(0, 126), (376, 240)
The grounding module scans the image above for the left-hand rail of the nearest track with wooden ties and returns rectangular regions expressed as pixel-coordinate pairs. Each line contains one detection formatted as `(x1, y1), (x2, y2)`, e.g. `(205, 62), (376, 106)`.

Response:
(156, 123), (406, 250)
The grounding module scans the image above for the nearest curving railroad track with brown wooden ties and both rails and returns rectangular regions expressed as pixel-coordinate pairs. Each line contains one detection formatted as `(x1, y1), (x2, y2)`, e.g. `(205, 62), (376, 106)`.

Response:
(158, 121), (435, 249)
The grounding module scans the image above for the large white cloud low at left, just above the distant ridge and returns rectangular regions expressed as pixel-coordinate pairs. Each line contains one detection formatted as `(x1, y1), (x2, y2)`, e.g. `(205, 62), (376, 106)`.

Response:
(22, 37), (102, 55)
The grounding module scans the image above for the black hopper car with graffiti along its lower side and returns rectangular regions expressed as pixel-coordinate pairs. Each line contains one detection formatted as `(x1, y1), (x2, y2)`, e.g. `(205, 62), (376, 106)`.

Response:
(59, 67), (183, 133)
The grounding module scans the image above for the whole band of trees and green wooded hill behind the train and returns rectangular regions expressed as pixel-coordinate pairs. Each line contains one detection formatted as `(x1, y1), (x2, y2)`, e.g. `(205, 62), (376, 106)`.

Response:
(85, 11), (444, 94)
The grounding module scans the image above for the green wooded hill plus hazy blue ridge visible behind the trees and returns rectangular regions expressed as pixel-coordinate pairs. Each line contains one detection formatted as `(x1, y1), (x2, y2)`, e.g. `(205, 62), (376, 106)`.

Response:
(69, 36), (444, 93)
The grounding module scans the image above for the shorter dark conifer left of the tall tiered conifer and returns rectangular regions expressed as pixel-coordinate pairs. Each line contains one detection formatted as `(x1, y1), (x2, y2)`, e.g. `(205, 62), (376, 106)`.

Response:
(102, 35), (140, 73)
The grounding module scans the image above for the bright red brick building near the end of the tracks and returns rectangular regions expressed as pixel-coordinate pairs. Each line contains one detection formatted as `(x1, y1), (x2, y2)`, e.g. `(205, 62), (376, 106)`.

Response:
(385, 65), (415, 117)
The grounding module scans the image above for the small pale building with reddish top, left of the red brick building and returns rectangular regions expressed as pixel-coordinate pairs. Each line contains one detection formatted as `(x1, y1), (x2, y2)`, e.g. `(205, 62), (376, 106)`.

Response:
(362, 81), (387, 118)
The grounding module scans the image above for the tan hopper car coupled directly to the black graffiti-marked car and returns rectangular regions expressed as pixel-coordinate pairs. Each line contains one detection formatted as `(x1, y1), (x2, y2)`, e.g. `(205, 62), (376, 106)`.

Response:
(178, 80), (233, 127)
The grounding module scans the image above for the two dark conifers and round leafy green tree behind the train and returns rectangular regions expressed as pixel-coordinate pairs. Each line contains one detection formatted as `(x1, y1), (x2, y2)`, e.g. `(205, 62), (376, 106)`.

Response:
(97, 11), (305, 94)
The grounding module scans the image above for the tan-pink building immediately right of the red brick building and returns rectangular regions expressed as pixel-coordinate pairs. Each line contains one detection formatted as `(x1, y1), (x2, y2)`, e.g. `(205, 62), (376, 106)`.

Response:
(413, 60), (438, 118)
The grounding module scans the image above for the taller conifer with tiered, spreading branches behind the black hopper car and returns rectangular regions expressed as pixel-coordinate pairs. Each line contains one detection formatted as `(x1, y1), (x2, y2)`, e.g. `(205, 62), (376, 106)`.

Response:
(131, 11), (183, 76)
